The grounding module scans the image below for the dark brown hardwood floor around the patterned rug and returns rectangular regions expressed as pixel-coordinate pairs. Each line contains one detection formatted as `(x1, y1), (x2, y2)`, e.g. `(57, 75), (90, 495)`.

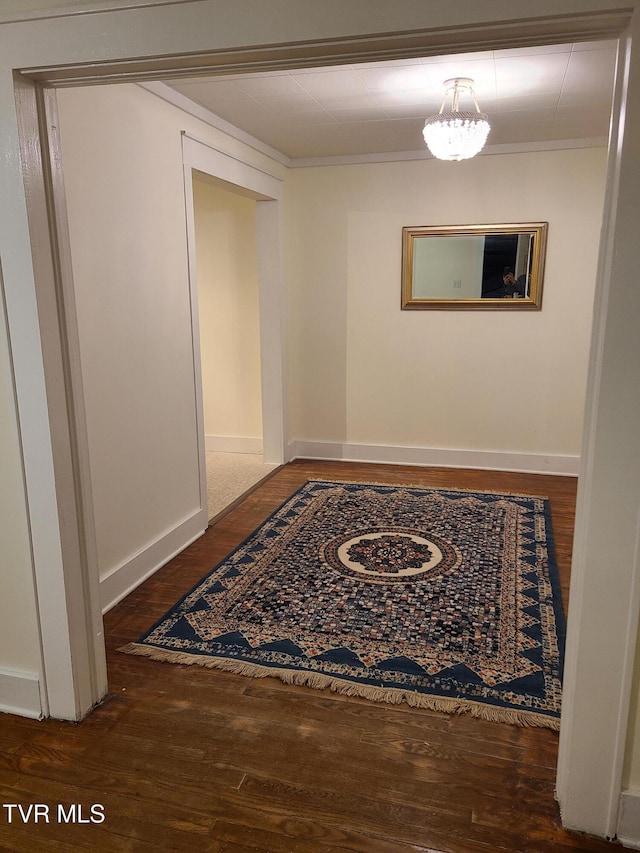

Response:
(0, 461), (619, 853)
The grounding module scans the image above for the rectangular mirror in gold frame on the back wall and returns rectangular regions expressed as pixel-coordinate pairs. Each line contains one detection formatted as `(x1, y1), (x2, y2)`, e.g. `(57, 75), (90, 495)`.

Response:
(402, 222), (548, 311)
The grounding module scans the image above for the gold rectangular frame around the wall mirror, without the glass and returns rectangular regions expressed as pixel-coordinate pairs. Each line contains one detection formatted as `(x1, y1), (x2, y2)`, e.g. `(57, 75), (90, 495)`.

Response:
(402, 222), (549, 311)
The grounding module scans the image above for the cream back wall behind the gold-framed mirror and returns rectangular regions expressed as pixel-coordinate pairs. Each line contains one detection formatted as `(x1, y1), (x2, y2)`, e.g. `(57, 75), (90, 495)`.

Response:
(287, 149), (606, 460)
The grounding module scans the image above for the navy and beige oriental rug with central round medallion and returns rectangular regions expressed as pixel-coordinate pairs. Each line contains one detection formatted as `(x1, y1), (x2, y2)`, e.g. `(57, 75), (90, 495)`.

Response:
(121, 480), (564, 729)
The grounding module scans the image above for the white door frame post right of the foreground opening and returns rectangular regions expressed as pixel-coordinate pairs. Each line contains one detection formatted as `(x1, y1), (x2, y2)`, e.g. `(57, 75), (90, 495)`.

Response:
(556, 25), (640, 838)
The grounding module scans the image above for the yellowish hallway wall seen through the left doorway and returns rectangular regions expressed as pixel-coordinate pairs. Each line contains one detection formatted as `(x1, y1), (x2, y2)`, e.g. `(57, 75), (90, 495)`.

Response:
(193, 173), (262, 450)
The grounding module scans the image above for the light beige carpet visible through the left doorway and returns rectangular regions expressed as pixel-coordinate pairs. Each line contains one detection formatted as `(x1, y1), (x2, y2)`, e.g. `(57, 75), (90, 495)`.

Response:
(206, 450), (278, 519)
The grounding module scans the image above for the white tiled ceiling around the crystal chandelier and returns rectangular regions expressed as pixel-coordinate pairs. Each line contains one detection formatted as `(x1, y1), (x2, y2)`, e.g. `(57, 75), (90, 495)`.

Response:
(164, 41), (616, 159)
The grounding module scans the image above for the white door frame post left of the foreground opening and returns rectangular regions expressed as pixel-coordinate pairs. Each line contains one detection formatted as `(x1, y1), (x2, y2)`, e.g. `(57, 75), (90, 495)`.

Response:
(10, 79), (107, 720)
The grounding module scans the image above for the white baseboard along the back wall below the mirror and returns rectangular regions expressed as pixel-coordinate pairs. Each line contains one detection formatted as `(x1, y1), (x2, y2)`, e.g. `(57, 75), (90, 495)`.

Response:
(288, 441), (580, 477)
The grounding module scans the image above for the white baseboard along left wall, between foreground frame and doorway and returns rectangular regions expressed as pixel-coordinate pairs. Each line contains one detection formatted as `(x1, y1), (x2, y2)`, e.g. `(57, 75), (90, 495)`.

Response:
(100, 509), (209, 613)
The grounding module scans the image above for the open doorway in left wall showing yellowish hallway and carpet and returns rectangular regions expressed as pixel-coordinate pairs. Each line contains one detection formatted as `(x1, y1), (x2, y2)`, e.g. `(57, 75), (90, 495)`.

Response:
(189, 171), (278, 521)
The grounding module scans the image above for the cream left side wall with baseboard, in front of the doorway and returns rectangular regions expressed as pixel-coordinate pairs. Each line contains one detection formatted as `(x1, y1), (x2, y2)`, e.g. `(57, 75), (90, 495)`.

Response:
(58, 84), (281, 608)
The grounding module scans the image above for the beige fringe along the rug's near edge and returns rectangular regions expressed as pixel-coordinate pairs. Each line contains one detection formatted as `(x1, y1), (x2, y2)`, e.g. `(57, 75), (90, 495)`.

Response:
(119, 643), (560, 731)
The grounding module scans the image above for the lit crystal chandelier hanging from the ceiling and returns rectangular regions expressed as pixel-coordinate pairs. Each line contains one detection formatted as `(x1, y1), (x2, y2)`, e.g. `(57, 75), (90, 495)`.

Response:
(422, 77), (491, 160)
